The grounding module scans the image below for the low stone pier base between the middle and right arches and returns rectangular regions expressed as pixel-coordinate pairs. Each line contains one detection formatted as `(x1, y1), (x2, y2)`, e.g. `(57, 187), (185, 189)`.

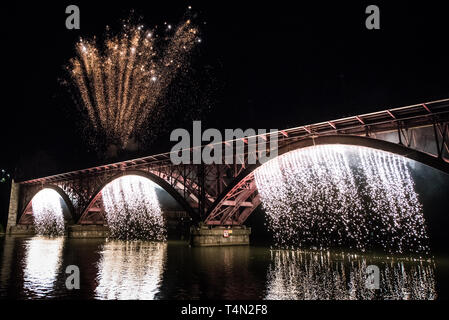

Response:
(190, 225), (251, 247)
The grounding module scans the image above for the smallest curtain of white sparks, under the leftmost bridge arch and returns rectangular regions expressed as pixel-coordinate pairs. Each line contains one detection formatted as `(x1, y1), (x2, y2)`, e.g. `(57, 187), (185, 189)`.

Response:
(31, 189), (65, 236)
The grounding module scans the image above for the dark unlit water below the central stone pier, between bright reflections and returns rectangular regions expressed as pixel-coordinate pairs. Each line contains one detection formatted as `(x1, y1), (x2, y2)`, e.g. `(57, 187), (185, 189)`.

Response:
(160, 243), (266, 300)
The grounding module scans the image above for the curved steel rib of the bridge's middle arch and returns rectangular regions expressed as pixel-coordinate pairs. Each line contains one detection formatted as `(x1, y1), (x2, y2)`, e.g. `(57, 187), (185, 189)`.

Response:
(77, 170), (198, 224)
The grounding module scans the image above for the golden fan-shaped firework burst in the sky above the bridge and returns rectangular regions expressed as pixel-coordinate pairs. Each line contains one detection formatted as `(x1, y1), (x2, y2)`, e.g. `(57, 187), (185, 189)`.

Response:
(67, 20), (200, 149)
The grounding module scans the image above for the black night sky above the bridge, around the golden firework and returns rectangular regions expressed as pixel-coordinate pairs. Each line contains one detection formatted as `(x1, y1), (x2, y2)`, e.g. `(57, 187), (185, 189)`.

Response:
(0, 1), (449, 179)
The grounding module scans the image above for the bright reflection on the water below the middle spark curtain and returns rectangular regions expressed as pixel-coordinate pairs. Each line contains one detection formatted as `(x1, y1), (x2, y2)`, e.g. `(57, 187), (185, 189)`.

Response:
(95, 241), (167, 300)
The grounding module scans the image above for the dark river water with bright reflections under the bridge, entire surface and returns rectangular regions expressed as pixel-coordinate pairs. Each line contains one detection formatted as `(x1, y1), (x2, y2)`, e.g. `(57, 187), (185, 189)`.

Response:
(0, 236), (449, 300)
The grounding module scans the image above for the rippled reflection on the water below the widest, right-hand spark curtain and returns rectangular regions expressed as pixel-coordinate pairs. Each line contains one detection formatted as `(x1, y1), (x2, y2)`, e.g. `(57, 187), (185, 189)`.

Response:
(265, 250), (436, 300)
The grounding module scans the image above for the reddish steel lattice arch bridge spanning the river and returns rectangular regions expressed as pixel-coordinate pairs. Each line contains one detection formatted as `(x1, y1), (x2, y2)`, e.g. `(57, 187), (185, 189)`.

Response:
(8, 99), (449, 231)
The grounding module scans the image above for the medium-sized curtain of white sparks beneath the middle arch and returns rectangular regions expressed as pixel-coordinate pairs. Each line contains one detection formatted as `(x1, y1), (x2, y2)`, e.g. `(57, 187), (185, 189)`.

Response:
(101, 175), (167, 241)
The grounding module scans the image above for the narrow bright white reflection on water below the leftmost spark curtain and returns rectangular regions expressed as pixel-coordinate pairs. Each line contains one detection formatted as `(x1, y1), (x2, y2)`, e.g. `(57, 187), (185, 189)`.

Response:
(23, 237), (64, 298)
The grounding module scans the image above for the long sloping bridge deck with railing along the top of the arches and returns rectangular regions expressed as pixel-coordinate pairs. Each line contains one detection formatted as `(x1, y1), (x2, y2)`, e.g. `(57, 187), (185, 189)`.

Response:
(19, 99), (449, 185)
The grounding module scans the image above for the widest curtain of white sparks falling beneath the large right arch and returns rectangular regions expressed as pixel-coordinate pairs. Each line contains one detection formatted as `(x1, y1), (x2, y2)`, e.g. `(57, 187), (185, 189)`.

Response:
(254, 145), (429, 254)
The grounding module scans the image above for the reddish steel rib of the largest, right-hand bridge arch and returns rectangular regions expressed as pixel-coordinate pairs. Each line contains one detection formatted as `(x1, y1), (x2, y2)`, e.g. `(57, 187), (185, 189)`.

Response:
(205, 135), (449, 225)
